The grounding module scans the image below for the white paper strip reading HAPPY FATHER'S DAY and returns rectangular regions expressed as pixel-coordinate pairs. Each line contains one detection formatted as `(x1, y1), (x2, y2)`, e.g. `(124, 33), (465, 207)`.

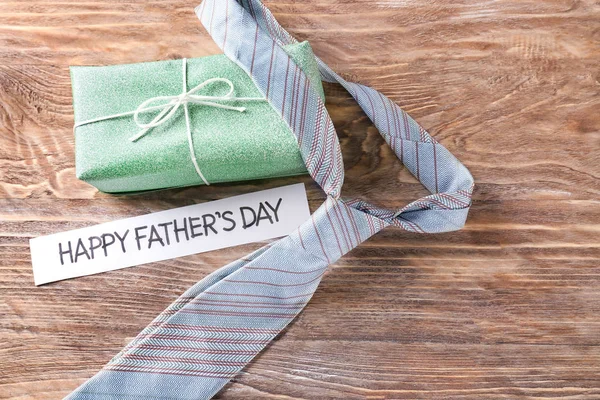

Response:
(29, 183), (310, 285)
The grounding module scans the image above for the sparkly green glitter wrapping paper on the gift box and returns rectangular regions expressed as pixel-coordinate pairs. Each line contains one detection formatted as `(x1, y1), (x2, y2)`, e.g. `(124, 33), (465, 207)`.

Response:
(71, 42), (324, 193)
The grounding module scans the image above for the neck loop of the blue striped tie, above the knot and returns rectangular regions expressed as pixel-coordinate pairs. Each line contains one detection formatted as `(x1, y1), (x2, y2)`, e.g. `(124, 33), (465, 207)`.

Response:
(196, 0), (474, 233)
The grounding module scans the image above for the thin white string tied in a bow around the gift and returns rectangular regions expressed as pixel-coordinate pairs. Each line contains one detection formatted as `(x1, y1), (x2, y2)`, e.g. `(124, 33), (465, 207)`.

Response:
(73, 58), (266, 185)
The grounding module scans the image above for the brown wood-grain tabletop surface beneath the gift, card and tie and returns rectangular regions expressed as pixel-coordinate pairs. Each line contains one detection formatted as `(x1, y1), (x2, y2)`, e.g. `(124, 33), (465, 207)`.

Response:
(0, 0), (600, 399)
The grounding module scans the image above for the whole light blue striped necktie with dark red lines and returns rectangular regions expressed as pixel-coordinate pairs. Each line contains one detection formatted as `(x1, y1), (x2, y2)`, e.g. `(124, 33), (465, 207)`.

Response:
(67, 0), (473, 400)
